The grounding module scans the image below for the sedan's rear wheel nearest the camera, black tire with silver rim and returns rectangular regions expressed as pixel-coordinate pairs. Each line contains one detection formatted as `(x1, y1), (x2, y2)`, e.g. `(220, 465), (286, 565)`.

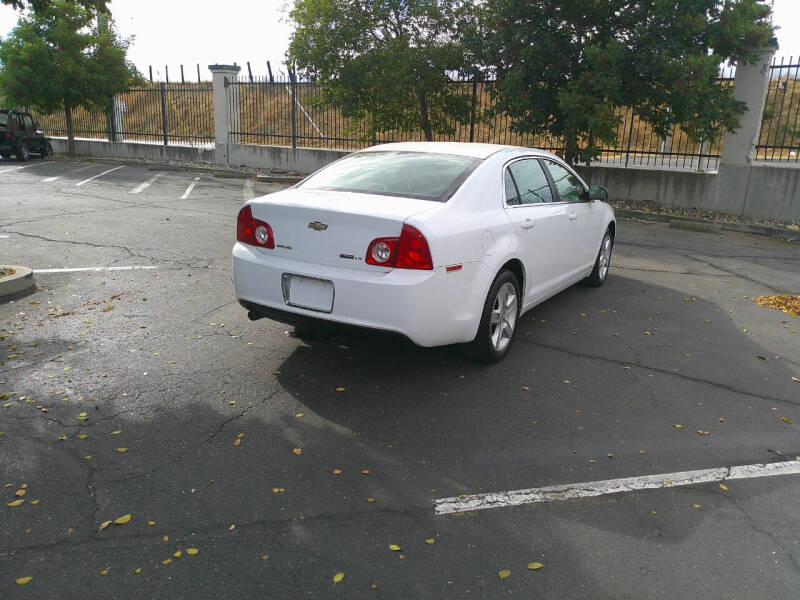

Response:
(464, 271), (521, 363)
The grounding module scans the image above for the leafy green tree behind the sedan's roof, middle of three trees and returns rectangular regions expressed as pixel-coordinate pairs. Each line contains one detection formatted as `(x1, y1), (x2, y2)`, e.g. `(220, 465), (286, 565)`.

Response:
(288, 0), (471, 140)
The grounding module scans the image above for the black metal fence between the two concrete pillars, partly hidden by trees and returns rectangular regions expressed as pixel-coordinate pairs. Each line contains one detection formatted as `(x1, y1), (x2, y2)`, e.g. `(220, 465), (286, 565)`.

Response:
(226, 69), (733, 170)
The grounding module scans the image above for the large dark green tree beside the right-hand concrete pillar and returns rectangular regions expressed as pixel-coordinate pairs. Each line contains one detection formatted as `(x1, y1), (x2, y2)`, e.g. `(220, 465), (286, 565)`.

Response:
(470, 0), (773, 162)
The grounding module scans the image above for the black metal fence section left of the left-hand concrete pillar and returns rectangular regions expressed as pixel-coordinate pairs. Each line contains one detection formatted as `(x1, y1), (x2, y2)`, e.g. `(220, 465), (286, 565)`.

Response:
(38, 82), (214, 145)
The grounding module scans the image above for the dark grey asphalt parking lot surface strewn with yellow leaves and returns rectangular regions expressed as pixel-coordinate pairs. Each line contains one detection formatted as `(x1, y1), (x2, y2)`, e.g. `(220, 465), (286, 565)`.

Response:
(0, 160), (800, 599)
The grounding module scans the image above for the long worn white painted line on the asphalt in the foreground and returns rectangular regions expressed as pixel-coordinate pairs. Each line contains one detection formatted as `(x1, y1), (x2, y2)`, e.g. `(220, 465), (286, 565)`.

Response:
(433, 460), (800, 515)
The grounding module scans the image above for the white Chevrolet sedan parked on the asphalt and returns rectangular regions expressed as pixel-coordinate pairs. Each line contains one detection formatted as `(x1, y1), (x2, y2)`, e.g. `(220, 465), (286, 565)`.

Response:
(233, 142), (616, 361)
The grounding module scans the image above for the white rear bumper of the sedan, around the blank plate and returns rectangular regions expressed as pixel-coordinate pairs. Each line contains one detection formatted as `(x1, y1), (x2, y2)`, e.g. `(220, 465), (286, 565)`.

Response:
(233, 242), (490, 346)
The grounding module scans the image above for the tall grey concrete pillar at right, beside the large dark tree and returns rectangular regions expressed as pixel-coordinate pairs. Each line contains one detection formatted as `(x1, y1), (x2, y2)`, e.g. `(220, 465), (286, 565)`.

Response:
(720, 42), (778, 167)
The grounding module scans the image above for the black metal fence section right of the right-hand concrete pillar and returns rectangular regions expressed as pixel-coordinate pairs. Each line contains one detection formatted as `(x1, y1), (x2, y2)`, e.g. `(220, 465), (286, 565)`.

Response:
(756, 57), (800, 162)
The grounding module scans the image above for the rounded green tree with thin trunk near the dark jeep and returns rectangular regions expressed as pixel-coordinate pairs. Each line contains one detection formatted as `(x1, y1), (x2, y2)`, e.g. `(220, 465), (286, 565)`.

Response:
(0, 0), (140, 154)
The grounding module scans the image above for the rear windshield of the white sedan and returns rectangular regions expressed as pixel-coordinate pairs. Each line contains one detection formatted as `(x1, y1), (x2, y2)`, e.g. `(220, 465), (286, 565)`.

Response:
(302, 151), (481, 202)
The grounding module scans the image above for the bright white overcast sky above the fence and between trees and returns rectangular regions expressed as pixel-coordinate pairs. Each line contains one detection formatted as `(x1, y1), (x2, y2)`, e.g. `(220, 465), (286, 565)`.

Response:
(0, 0), (800, 81)
